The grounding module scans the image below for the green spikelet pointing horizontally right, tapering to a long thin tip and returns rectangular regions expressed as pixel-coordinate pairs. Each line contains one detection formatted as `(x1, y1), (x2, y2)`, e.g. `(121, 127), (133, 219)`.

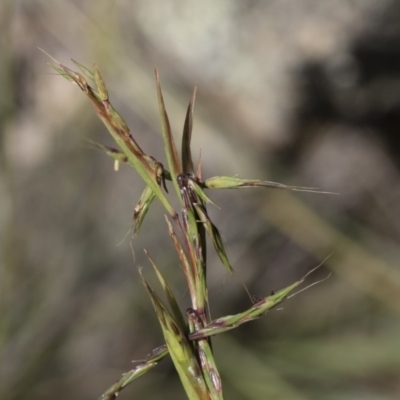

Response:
(204, 176), (338, 194)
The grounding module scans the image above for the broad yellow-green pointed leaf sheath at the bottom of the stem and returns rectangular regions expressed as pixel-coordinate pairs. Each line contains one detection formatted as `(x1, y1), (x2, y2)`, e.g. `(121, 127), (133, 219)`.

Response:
(142, 275), (208, 400)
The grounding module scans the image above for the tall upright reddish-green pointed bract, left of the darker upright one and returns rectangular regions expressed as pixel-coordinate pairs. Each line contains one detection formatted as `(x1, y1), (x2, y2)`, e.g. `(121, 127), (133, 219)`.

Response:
(155, 68), (182, 199)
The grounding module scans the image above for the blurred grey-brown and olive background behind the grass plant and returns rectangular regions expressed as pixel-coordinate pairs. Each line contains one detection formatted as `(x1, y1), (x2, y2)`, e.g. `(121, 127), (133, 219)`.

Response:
(0, 0), (400, 400)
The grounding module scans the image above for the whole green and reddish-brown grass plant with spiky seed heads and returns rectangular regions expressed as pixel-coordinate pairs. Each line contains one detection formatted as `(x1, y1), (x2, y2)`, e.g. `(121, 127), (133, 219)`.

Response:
(50, 57), (327, 400)
